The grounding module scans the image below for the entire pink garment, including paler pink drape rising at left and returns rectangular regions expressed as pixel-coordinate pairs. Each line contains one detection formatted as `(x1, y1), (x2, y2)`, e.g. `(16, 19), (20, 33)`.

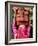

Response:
(12, 19), (30, 39)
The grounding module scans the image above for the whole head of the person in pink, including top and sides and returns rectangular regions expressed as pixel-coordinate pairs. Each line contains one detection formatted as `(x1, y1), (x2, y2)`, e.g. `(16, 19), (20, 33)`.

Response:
(12, 7), (30, 25)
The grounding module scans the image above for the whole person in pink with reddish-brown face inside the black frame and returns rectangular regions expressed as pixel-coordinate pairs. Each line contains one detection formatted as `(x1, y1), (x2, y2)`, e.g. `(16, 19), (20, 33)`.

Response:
(12, 7), (32, 39)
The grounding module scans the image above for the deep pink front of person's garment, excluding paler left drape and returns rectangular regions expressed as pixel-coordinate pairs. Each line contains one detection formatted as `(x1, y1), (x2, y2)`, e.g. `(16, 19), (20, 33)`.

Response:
(16, 27), (30, 39)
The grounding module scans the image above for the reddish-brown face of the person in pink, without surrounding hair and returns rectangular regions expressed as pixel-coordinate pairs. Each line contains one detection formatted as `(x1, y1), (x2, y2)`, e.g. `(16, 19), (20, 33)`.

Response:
(16, 9), (29, 25)
